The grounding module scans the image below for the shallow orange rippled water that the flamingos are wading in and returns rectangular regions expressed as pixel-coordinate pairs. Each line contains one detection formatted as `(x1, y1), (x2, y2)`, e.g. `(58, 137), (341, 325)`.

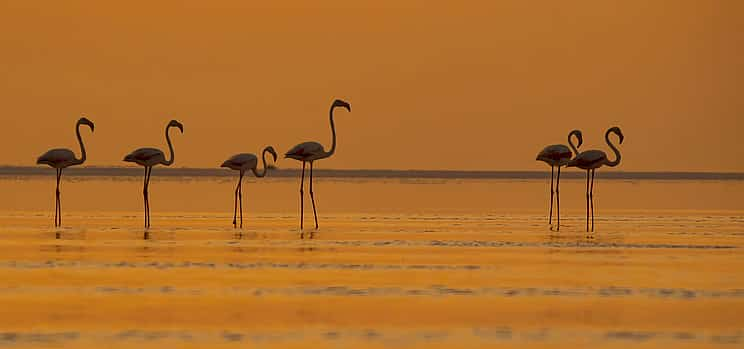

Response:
(0, 175), (744, 348)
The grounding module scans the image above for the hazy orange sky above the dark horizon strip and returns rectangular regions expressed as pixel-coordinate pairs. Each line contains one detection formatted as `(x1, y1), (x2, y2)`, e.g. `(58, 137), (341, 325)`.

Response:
(0, 0), (744, 171)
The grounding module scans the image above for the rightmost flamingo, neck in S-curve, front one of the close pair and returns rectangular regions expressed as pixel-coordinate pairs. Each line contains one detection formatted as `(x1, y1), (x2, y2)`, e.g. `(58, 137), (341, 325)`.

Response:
(566, 126), (625, 232)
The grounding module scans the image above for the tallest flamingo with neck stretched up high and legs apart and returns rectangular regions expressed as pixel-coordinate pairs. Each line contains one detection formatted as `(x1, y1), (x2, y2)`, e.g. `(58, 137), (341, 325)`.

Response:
(284, 99), (351, 231)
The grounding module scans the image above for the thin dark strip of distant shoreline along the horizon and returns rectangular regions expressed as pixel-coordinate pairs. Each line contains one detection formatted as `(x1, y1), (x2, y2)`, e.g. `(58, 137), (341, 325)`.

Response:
(0, 166), (744, 181)
